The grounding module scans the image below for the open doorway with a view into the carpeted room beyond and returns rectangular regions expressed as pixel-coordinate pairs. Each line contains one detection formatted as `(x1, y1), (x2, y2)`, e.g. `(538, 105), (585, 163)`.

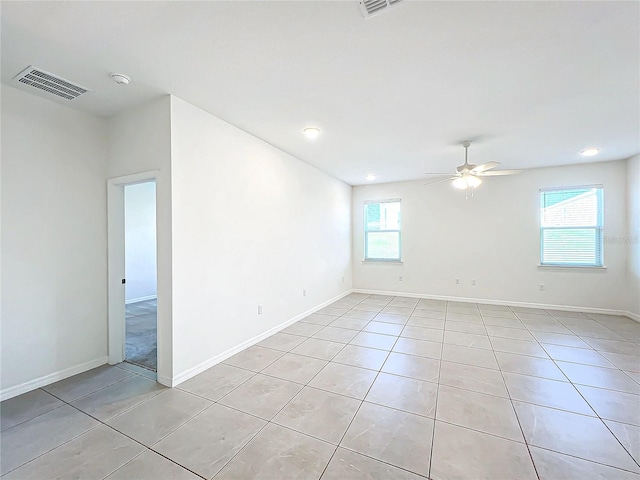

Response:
(124, 180), (158, 372)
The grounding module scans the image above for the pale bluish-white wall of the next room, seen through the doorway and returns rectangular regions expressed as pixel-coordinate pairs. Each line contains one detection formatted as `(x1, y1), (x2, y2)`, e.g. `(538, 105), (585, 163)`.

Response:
(124, 182), (158, 303)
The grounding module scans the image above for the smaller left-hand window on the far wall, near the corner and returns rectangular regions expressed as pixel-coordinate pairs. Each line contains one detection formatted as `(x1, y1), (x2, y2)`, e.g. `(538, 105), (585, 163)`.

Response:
(364, 199), (400, 262)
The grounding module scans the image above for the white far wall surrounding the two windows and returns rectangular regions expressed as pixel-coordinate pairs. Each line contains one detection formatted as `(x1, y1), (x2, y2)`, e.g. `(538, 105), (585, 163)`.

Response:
(353, 161), (628, 310)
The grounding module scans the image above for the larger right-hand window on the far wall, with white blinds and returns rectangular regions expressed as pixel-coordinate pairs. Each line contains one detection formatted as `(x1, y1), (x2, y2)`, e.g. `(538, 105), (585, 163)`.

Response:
(540, 186), (604, 267)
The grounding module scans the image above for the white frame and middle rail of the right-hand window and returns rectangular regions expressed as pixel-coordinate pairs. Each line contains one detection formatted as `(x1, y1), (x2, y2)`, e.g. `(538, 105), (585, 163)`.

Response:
(538, 185), (606, 269)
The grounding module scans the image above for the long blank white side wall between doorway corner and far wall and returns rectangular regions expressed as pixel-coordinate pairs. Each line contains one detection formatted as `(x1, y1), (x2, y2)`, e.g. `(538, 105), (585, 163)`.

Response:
(171, 97), (351, 377)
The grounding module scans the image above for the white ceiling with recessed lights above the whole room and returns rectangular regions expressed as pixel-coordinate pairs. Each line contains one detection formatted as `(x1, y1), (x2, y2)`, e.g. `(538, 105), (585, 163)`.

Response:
(1, 1), (640, 185)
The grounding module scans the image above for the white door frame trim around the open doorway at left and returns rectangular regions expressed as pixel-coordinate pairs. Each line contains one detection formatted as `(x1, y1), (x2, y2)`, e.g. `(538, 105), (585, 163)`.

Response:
(107, 170), (162, 365)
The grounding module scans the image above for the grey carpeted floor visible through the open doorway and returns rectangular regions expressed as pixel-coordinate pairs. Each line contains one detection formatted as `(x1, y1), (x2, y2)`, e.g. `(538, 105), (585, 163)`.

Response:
(125, 300), (158, 372)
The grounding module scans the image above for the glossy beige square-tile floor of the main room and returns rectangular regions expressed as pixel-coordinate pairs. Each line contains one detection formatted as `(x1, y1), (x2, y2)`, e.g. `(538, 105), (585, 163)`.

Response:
(0, 294), (640, 480)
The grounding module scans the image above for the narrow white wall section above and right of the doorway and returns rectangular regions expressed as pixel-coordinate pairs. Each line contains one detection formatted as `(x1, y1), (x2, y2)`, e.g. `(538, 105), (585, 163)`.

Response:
(108, 96), (173, 384)
